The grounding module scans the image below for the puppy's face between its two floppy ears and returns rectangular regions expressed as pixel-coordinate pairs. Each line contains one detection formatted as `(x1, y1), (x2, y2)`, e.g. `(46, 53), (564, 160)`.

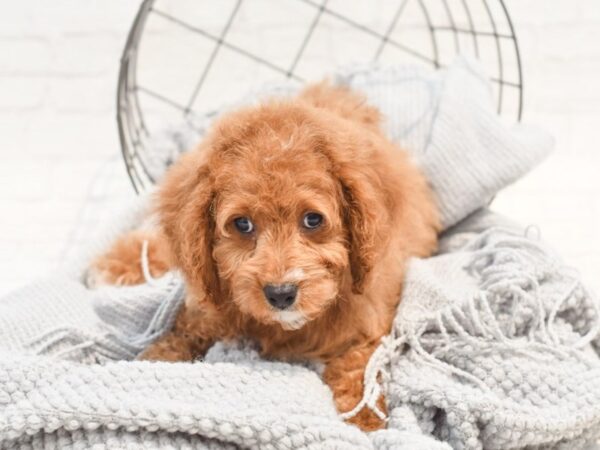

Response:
(213, 134), (349, 329)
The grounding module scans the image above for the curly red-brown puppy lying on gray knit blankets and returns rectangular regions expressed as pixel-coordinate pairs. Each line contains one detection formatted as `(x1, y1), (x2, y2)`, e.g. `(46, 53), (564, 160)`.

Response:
(91, 83), (440, 430)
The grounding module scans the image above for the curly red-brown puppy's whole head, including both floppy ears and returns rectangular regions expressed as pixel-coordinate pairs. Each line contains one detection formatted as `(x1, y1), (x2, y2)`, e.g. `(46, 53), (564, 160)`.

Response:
(159, 102), (434, 329)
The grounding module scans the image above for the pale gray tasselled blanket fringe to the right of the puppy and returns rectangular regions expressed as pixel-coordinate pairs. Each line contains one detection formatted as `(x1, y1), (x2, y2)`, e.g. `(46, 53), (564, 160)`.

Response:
(341, 227), (600, 420)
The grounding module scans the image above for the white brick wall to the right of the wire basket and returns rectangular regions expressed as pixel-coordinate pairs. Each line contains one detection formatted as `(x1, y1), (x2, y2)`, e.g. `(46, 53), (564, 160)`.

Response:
(494, 0), (600, 292)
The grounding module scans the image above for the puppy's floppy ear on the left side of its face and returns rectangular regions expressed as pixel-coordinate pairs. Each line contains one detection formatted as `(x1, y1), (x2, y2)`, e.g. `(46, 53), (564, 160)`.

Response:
(158, 150), (220, 301)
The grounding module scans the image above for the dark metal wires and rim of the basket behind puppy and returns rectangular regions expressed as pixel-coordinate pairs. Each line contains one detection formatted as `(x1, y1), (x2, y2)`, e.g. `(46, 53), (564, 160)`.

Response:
(117, 0), (523, 193)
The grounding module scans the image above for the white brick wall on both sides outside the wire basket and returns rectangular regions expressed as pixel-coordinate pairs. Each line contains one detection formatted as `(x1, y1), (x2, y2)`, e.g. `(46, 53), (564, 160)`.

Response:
(0, 0), (600, 293)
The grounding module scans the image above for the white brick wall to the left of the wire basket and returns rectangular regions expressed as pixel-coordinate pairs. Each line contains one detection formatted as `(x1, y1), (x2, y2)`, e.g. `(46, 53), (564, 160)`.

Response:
(0, 0), (139, 293)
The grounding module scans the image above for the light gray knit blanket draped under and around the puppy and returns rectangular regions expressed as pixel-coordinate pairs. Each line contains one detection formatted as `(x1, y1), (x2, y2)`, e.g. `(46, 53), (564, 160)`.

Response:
(0, 61), (600, 450)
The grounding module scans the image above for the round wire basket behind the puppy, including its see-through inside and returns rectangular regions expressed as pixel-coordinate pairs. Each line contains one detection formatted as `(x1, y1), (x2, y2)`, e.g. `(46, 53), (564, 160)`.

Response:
(117, 0), (523, 192)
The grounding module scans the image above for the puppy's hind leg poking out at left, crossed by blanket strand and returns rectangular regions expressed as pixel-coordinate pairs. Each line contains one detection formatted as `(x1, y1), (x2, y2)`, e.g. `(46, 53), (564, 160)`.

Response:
(86, 231), (169, 289)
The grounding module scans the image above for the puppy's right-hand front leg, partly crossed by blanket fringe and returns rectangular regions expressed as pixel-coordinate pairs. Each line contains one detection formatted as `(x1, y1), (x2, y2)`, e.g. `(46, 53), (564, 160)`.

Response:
(323, 343), (386, 431)
